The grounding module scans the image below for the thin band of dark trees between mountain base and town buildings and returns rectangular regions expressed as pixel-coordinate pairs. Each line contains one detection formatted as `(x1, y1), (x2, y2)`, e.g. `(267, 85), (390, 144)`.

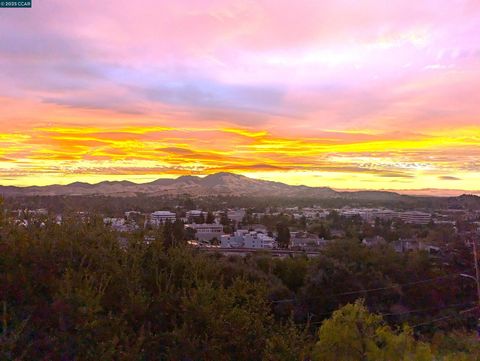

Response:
(6, 194), (480, 216)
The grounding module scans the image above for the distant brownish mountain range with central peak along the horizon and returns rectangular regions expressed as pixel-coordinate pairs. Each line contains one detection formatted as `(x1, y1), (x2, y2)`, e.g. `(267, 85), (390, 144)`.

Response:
(0, 172), (480, 206)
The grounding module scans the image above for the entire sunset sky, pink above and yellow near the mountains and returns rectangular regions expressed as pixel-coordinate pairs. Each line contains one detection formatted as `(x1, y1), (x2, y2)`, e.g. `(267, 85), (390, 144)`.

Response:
(0, 0), (480, 191)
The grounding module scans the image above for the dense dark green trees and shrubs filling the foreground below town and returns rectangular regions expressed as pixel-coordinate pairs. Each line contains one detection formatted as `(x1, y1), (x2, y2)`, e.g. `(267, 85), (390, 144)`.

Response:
(0, 197), (479, 361)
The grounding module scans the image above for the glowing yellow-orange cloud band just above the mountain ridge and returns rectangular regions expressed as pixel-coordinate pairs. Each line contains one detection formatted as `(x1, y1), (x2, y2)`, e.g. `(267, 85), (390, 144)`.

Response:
(0, 126), (480, 187)
